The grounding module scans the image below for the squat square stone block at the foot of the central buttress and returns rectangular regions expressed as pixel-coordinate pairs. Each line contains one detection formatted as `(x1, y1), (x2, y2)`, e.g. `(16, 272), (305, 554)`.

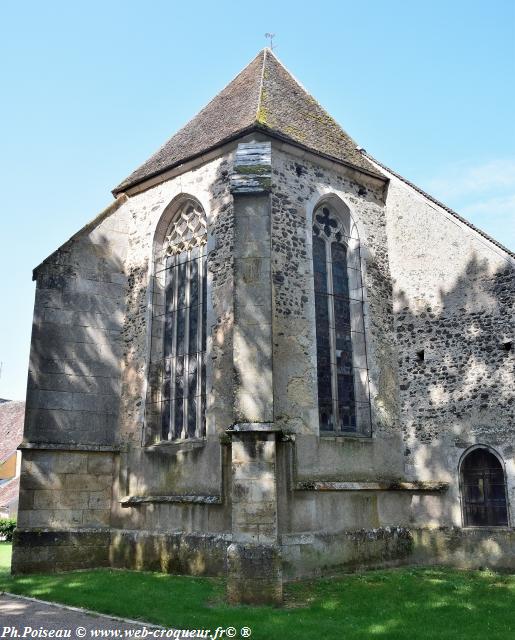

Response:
(227, 543), (283, 605)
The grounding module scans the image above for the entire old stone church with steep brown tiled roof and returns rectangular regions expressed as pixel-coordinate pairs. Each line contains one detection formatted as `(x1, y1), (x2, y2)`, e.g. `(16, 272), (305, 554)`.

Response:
(13, 49), (515, 602)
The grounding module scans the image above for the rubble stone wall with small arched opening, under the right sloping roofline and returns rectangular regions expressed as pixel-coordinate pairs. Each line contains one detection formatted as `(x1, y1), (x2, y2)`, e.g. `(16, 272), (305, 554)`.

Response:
(374, 161), (515, 526)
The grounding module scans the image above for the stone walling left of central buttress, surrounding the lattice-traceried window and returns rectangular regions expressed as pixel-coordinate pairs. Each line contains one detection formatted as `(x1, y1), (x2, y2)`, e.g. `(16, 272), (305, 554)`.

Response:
(19, 146), (240, 550)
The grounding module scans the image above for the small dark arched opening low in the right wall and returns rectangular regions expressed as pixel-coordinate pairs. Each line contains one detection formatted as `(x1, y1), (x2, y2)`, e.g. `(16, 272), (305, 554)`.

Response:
(461, 447), (508, 527)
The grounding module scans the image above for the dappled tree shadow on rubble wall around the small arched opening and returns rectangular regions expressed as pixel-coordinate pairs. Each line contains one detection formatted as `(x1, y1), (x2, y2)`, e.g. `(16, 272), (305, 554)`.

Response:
(394, 254), (515, 525)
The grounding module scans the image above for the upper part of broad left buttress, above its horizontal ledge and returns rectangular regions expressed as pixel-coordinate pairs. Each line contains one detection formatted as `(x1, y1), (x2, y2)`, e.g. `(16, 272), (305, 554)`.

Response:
(25, 198), (127, 445)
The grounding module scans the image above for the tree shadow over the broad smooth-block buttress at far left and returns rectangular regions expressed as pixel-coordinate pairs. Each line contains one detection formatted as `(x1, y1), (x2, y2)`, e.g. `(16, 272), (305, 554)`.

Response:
(15, 229), (127, 536)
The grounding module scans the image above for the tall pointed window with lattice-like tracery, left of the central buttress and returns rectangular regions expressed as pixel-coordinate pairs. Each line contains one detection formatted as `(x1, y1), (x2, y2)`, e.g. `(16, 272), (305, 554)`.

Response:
(147, 198), (207, 442)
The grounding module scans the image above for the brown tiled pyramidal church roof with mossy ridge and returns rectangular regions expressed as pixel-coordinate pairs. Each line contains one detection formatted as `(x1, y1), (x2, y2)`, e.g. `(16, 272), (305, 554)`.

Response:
(113, 49), (384, 195)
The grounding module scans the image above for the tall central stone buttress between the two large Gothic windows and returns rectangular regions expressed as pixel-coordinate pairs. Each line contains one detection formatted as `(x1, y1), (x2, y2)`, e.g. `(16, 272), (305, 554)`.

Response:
(227, 142), (282, 602)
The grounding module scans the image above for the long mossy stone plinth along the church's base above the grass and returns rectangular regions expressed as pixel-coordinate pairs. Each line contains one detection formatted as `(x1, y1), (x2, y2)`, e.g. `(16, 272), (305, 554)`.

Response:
(12, 527), (515, 584)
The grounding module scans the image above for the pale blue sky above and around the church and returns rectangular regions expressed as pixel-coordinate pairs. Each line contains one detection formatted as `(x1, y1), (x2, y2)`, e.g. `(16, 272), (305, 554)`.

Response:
(0, 0), (515, 399)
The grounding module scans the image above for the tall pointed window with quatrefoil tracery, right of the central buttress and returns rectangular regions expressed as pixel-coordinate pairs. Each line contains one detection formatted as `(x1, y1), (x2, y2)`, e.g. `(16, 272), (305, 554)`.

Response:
(313, 203), (371, 436)
